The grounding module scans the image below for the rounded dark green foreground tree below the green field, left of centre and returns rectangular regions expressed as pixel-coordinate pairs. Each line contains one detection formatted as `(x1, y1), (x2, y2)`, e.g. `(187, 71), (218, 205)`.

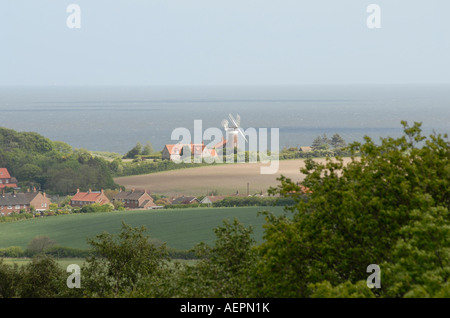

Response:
(82, 222), (168, 297)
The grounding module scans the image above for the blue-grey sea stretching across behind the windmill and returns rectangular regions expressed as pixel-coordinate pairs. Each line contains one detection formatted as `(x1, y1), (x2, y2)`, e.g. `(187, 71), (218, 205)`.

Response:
(0, 86), (450, 154)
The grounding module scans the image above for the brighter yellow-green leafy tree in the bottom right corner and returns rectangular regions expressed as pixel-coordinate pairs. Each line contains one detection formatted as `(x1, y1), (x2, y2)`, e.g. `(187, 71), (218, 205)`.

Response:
(381, 207), (450, 298)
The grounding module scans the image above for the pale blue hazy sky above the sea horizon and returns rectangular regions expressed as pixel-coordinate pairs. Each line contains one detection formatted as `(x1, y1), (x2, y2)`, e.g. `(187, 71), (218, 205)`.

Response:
(0, 0), (450, 85)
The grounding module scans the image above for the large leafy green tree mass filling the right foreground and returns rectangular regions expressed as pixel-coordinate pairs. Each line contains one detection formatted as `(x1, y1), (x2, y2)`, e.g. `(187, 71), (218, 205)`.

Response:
(257, 122), (450, 297)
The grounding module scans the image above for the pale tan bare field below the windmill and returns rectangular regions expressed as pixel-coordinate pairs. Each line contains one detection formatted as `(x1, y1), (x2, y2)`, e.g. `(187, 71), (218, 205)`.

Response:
(114, 158), (350, 196)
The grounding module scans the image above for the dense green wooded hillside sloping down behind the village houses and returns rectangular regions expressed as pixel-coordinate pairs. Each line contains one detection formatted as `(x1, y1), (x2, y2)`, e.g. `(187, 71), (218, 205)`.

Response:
(0, 127), (119, 195)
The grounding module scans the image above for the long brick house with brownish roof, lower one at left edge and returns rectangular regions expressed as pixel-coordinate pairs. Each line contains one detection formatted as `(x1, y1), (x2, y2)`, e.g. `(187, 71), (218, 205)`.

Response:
(0, 188), (51, 215)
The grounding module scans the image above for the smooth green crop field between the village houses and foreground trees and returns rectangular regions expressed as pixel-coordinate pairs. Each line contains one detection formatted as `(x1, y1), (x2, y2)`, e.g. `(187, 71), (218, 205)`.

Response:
(0, 207), (283, 250)
